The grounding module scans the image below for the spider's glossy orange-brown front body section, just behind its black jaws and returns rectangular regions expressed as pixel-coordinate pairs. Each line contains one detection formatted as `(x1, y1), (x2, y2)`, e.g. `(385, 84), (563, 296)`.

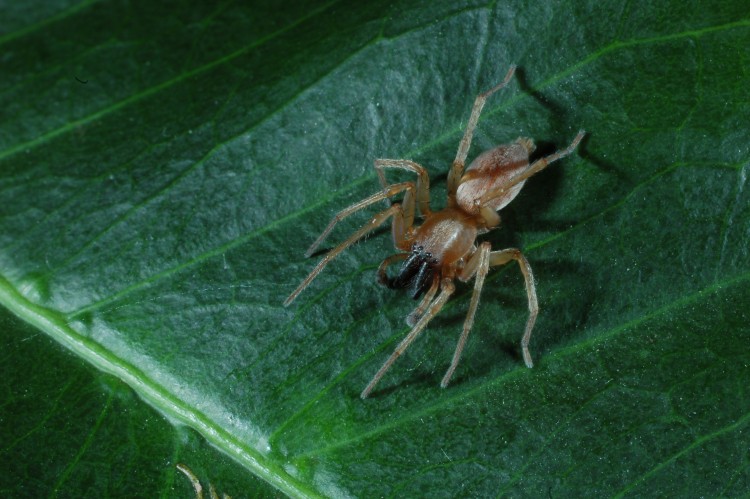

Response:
(414, 208), (477, 266)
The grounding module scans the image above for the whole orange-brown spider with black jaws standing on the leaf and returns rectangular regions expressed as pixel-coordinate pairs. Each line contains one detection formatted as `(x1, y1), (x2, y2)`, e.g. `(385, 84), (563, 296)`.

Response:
(284, 65), (585, 399)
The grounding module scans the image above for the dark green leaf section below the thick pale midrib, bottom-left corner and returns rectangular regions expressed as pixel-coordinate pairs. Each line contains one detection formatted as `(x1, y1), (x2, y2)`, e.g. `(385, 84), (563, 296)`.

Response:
(0, 309), (282, 497)
